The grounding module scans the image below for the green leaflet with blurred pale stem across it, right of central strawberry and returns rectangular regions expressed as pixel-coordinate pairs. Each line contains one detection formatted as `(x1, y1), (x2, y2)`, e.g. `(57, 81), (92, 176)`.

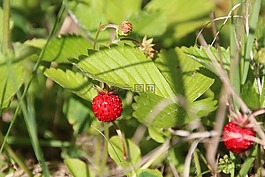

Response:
(132, 93), (188, 128)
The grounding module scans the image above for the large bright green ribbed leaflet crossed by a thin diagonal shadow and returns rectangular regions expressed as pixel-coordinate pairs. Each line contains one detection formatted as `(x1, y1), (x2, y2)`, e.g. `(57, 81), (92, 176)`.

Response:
(78, 46), (174, 100)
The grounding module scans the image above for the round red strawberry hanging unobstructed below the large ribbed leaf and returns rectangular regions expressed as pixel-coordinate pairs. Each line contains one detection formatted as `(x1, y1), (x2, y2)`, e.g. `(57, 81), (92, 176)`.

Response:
(92, 92), (122, 122)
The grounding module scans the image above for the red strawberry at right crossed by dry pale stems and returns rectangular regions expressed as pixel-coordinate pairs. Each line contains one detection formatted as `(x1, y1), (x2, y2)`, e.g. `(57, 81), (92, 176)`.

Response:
(223, 122), (255, 154)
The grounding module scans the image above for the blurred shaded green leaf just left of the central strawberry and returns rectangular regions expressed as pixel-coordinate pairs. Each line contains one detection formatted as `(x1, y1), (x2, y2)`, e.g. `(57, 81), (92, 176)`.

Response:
(63, 98), (92, 136)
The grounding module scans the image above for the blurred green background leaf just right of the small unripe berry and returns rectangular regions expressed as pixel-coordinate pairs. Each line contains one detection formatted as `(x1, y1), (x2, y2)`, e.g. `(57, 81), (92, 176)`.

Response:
(129, 11), (166, 37)
